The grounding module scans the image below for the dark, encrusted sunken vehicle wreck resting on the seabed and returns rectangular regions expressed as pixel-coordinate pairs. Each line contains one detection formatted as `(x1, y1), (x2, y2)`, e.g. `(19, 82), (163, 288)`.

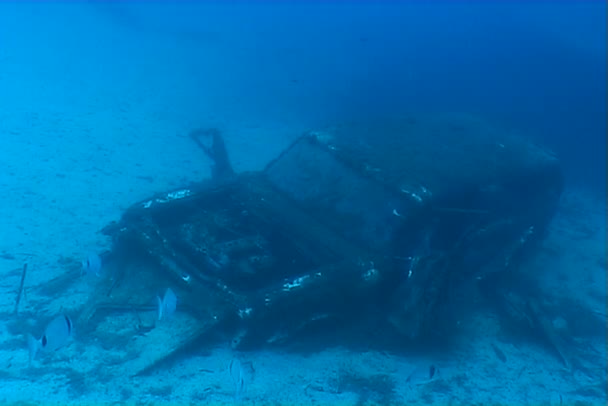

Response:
(81, 119), (562, 373)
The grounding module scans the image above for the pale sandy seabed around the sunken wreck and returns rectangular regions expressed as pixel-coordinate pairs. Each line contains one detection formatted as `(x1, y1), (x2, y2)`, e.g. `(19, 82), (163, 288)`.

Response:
(0, 3), (606, 405)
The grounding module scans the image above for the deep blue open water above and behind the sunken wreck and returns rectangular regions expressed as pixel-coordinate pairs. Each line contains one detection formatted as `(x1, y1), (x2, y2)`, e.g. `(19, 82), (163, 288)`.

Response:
(98, 1), (606, 193)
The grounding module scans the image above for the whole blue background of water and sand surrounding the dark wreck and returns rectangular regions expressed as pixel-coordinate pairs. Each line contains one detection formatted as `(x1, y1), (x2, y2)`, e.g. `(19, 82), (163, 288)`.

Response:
(0, 0), (607, 404)
